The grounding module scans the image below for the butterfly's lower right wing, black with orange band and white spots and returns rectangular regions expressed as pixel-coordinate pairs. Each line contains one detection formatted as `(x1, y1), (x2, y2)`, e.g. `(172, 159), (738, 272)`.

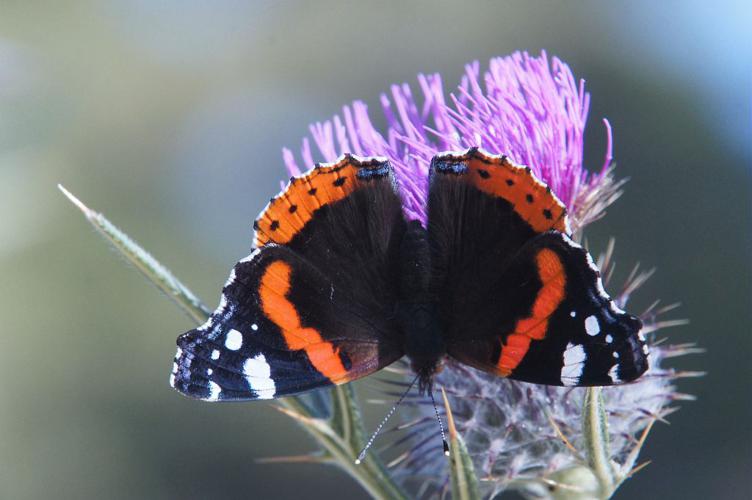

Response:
(449, 231), (647, 386)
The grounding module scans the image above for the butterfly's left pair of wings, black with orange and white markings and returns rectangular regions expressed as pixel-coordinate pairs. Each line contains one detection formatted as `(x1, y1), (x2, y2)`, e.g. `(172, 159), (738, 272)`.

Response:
(170, 156), (405, 400)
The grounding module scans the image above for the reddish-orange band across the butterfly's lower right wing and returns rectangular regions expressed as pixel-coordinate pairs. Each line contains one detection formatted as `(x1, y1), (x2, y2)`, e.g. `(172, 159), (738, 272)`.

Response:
(496, 248), (567, 377)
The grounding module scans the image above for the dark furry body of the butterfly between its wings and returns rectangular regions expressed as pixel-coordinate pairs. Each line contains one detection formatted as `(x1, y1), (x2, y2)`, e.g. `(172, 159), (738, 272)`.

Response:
(397, 221), (446, 392)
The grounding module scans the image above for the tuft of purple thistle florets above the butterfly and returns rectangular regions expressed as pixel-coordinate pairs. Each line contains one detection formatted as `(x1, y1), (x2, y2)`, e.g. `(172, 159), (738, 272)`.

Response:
(283, 52), (613, 229)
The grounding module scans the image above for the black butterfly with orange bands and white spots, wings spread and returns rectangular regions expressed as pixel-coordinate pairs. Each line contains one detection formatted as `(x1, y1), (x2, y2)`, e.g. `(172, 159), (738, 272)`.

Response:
(170, 148), (648, 401)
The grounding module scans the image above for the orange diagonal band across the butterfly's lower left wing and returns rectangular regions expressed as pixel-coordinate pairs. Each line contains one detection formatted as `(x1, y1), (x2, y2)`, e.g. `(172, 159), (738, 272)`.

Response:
(259, 260), (347, 383)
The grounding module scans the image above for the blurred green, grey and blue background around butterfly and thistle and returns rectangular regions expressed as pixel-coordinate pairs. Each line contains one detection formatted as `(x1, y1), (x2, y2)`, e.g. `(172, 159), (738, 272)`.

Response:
(0, 0), (752, 499)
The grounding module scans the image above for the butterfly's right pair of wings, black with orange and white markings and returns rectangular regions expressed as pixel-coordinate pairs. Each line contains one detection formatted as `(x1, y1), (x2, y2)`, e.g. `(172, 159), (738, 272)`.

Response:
(429, 150), (647, 386)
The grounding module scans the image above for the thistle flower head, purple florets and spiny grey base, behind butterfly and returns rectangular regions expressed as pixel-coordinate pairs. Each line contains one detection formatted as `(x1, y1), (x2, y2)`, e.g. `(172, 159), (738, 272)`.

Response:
(283, 52), (692, 497)
